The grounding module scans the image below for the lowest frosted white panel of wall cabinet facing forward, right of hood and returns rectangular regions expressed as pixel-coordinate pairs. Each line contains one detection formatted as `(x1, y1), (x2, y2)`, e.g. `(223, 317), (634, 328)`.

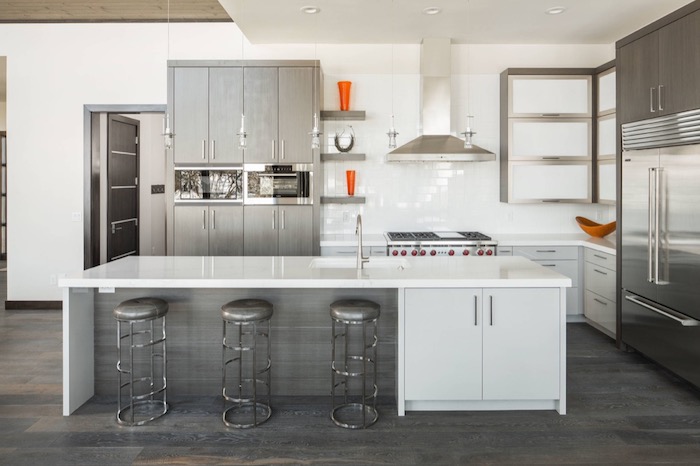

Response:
(508, 162), (592, 203)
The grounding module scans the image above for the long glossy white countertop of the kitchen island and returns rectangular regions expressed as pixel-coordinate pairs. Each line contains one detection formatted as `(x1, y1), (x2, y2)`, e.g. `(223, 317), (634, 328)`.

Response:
(58, 256), (571, 291)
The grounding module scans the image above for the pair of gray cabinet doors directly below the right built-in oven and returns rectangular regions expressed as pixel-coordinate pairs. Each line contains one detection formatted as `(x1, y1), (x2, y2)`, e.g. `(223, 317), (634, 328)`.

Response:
(243, 206), (313, 256)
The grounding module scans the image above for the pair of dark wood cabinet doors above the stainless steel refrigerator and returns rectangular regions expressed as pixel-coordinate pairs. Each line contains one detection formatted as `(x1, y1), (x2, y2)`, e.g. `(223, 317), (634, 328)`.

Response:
(617, 7), (700, 123)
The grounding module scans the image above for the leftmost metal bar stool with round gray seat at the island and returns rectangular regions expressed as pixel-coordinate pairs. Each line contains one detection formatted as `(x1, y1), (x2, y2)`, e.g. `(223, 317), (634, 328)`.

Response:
(113, 298), (169, 426)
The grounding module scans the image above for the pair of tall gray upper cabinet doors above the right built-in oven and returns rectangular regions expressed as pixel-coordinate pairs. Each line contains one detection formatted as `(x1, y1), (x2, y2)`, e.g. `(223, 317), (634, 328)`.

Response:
(244, 67), (313, 163)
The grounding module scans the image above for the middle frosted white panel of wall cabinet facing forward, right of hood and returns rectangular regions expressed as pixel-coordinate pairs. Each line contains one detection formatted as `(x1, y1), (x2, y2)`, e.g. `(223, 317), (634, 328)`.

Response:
(508, 118), (592, 161)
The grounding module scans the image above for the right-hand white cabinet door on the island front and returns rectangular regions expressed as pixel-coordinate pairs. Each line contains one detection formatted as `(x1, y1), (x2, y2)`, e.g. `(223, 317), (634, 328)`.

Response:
(483, 288), (565, 400)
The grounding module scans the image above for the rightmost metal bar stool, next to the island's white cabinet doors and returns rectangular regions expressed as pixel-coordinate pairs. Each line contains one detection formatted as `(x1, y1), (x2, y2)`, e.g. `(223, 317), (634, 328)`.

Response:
(331, 299), (379, 429)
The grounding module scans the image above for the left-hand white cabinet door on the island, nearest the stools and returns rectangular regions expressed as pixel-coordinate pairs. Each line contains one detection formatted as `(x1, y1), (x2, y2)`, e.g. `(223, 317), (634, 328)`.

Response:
(404, 289), (482, 400)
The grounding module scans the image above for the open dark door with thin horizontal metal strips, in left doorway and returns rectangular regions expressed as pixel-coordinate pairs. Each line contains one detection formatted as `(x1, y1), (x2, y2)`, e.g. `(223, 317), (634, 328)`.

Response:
(107, 114), (139, 261)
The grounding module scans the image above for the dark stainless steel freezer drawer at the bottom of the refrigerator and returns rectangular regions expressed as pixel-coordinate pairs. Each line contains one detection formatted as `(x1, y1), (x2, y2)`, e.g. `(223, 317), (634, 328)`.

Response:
(622, 292), (700, 386)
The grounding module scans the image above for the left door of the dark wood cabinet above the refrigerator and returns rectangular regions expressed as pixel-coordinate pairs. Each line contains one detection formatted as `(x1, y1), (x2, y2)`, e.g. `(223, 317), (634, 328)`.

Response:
(617, 32), (659, 123)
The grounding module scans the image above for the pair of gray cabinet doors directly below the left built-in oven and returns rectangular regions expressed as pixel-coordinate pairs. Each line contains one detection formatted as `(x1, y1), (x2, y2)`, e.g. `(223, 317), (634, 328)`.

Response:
(174, 205), (243, 256)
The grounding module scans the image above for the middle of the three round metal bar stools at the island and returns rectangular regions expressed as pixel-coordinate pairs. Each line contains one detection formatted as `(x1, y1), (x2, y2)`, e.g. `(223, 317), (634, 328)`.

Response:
(221, 299), (272, 429)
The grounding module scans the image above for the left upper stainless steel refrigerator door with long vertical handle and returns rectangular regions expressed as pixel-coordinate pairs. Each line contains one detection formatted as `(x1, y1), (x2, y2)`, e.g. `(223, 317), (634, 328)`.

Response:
(620, 149), (659, 300)
